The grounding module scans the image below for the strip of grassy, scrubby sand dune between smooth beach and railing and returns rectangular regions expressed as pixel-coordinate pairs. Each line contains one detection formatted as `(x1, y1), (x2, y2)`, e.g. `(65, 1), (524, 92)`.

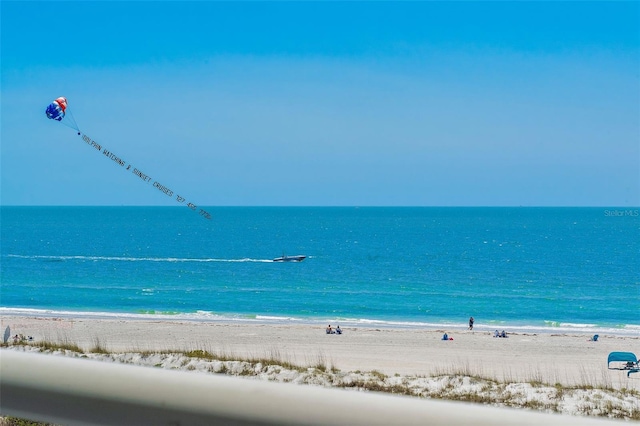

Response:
(3, 339), (640, 421)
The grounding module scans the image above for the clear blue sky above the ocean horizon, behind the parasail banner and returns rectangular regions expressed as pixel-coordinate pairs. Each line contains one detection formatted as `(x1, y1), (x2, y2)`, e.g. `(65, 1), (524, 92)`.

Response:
(0, 1), (640, 206)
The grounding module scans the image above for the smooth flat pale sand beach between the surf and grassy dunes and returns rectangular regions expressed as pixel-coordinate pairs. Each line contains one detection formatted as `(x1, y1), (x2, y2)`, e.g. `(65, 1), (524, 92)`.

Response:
(1, 316), (640, 390)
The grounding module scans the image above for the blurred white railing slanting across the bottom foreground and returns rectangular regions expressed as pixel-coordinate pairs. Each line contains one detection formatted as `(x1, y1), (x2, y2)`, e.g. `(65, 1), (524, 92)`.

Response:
(0, 350), (620, 426)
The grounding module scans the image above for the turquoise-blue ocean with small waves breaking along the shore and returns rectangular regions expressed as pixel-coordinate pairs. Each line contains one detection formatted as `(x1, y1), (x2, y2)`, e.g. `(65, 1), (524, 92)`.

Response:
(0, 206), (640, 336)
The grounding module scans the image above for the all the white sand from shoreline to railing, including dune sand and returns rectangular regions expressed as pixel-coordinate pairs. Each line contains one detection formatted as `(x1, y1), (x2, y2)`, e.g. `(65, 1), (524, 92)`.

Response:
(0, 315), (640, 419)
